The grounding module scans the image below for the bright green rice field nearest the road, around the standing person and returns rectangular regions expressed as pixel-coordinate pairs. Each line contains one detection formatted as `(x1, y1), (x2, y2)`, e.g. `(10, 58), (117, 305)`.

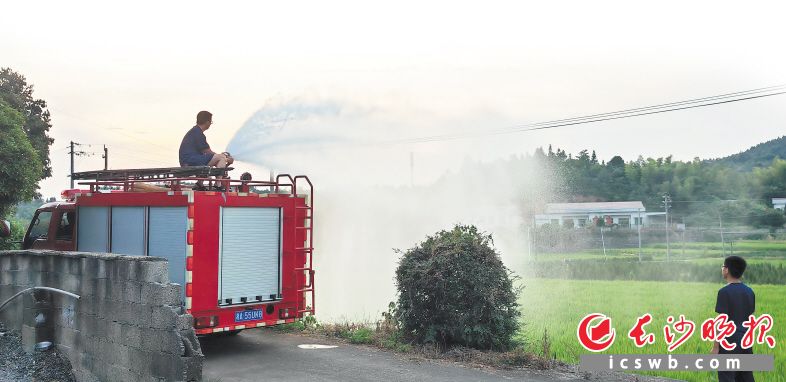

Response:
(518, 279), (786, 382)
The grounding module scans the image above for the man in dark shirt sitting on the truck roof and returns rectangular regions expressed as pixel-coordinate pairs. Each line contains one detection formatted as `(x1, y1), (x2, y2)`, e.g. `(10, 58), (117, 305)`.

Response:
(180, 111), (235, 168)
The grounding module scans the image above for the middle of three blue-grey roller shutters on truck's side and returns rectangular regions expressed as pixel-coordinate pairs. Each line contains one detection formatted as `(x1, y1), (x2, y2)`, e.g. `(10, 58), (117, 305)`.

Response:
(111, 207), (145, 256)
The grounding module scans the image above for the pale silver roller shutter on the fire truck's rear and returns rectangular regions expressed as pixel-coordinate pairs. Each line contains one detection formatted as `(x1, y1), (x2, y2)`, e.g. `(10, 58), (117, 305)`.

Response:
(218, 207), (281, 305)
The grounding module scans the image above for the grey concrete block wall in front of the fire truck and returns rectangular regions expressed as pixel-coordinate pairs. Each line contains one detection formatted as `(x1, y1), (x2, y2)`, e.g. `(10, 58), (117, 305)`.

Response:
(0, 251), (203, 381)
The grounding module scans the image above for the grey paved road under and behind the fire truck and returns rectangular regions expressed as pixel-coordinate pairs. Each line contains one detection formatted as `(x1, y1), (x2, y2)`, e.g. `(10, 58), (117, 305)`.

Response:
(200, 329), (672, 382)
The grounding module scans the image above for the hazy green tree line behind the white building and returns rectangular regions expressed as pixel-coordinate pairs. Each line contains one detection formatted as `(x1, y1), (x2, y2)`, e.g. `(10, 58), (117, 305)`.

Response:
(532, 146), (786, 228)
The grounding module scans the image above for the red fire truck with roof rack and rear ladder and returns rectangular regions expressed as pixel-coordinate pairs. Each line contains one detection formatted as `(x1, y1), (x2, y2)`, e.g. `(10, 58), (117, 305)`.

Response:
(23, 167), (314, 335)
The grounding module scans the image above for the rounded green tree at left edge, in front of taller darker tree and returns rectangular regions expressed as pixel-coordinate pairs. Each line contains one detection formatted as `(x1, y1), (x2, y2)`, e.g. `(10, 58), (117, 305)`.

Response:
(0, 100), (42, 216)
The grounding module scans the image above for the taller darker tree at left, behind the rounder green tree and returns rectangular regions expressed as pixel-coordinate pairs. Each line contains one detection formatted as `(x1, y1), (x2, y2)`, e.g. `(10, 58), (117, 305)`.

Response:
(0, 68), (54, 179)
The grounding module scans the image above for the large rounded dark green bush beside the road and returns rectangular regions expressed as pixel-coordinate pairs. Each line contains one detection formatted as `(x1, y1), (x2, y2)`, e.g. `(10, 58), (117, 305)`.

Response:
(396, 225), (519, 350)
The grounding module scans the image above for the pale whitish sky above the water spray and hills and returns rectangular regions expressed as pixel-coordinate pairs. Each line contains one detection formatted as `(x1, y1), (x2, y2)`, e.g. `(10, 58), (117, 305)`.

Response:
(0, 1), (786, 195)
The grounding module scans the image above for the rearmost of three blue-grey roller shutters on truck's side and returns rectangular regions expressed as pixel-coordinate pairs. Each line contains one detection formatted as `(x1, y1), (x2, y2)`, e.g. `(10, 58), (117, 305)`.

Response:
(147, 207), (188, 296)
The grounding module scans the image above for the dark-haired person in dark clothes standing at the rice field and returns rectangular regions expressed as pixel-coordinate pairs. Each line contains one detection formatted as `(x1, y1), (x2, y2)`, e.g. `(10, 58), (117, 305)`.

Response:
(712, 256), (756, 382)
